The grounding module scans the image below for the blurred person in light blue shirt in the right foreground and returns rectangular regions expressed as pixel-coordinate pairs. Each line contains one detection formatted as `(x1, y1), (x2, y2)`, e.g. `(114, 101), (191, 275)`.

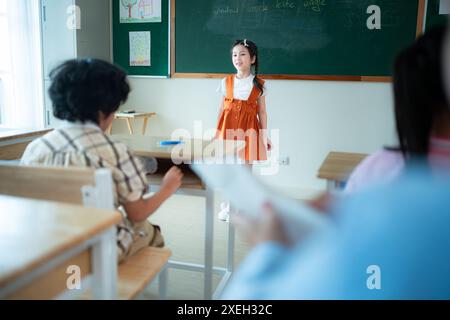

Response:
(222, 24), (450, 299)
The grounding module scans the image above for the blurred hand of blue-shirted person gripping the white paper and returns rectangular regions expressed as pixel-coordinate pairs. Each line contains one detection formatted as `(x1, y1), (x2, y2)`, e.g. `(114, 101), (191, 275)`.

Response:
(230, 204), (290, 246)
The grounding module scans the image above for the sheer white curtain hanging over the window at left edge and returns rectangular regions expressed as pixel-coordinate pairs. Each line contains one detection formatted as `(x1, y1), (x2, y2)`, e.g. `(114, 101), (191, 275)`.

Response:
(0, 0), (44, 128)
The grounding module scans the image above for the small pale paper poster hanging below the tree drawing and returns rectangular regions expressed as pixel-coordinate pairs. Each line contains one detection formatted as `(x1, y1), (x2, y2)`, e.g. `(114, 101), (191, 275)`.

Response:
(130, 31), (151, 67)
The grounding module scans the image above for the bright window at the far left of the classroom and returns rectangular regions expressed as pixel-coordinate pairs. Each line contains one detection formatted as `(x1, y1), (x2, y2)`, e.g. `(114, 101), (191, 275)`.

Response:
(0, 0), (43, 128)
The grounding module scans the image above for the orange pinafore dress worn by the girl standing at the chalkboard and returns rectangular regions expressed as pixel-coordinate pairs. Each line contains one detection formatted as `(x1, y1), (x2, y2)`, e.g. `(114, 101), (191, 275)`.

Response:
(216, 75), (267, 163)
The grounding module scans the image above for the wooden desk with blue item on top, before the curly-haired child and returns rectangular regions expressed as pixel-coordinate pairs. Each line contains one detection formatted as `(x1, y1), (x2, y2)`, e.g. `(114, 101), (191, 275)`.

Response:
(112, 135), (245, 299)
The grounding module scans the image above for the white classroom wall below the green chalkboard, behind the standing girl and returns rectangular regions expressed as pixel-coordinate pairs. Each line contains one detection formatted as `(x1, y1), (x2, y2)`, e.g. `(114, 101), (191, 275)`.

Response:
(117, 78), (396, 197)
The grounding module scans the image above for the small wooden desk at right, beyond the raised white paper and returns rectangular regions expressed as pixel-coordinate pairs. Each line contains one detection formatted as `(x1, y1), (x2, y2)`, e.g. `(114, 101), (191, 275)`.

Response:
(317, 152), (367, 190)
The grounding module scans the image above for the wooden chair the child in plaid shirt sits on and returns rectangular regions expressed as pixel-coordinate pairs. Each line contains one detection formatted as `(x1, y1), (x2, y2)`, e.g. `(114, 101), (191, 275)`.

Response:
(0, 161), (171, 299)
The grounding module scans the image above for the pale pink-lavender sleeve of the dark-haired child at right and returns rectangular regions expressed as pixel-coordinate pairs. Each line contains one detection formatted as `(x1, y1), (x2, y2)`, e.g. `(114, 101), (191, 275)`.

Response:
(344, 149), (404, 193)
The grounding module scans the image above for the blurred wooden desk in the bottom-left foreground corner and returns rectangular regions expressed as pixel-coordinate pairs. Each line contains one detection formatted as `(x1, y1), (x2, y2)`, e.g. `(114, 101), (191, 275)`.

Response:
(0, 195), (121, 299)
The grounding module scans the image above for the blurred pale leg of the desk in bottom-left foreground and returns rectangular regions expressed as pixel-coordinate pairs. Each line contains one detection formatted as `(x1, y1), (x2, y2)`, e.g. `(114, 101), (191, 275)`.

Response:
(92, 227), (118, 299)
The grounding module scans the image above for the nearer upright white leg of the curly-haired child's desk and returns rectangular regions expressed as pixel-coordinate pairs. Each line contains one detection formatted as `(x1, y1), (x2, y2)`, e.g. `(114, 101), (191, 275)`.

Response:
(204, 187), (214, 300)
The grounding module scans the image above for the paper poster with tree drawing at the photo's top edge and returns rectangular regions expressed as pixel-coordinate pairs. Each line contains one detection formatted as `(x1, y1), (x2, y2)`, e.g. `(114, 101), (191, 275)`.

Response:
(119, 0), (161, 23)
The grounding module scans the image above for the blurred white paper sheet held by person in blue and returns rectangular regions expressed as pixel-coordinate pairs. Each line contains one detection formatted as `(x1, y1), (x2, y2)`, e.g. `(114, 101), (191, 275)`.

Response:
(191, 164), (332, 242)
